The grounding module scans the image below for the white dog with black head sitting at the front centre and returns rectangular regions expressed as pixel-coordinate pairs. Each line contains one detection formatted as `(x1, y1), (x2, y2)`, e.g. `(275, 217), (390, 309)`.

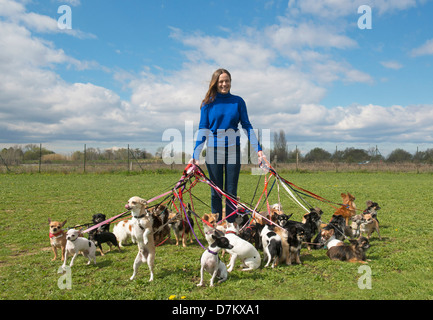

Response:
(197, 235), (233, 287)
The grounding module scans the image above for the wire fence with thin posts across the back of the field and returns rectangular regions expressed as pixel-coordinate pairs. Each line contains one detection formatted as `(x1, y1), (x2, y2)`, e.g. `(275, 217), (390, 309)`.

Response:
(0, 144), (433, 174)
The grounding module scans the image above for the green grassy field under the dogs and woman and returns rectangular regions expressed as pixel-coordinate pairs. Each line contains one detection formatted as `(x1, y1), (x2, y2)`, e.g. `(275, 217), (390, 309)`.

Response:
(0, 172), (433, 300)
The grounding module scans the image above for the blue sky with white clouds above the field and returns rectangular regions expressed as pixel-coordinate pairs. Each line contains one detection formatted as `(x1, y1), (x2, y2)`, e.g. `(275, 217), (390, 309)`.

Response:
(0, 0), (433, 155)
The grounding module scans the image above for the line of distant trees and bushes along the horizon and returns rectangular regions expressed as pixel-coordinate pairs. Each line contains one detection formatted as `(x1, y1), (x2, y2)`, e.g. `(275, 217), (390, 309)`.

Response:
(0, 139), (433, 165)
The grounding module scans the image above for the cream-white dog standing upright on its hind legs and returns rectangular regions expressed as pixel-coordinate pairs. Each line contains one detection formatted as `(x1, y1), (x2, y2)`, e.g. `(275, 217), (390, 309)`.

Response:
(125, 197), (155, 281)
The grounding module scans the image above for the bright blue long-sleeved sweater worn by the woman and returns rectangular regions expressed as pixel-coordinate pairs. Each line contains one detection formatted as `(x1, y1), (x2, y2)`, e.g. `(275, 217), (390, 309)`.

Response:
(193, 93), (262, 159)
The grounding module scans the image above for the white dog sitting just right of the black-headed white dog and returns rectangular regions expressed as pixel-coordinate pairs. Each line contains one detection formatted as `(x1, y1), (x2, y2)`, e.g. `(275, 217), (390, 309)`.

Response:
(225, 223), (262, 272)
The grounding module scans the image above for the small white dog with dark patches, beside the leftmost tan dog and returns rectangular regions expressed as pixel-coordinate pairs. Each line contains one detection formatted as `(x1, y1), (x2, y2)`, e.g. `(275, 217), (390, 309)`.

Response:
(62, 229), (96, 270)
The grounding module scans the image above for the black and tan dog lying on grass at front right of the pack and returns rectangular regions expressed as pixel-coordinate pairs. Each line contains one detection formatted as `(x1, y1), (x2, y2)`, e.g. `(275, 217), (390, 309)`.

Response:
(326, 237), (370, 264)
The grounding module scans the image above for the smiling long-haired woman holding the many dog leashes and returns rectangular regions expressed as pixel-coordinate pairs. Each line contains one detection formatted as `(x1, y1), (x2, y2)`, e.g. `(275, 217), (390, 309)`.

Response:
(189, 69), (264, 222)
